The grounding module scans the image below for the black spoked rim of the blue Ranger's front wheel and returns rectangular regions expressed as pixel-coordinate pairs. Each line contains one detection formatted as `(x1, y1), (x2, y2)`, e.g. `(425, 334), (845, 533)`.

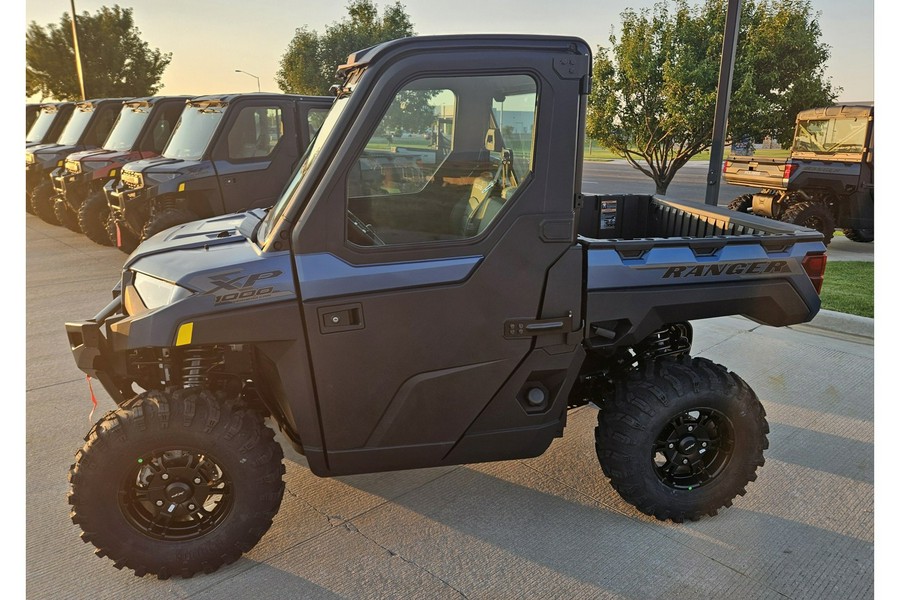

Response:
(119, 448), (234, 541)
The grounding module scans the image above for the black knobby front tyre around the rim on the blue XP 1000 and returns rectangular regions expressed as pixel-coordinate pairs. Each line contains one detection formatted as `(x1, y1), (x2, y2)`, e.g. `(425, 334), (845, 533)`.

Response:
(68, 388), (285, 579)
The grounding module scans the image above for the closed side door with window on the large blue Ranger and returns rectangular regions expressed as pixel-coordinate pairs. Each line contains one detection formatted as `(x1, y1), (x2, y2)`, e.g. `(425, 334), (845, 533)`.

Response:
(295, 44), (581, 474)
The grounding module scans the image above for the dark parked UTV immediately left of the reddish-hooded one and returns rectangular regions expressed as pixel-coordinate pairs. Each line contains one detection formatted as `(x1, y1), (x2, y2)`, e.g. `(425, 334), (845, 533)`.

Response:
(25, 98), (126, 225)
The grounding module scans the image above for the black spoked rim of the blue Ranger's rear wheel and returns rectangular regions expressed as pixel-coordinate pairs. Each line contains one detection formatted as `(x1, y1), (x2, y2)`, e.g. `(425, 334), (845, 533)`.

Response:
(651, 408), (734, 490)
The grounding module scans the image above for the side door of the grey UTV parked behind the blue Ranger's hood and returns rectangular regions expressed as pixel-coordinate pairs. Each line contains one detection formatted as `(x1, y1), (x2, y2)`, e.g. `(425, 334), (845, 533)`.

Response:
(212, 98), (300, 213)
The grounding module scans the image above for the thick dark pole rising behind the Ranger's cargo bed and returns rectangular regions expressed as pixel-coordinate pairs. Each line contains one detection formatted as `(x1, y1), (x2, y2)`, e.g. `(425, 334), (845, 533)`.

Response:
(706, 0), (741, 206)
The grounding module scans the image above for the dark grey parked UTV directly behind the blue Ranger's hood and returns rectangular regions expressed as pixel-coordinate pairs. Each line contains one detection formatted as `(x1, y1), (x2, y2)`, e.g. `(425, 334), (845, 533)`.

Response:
(105, 93), (334, 253)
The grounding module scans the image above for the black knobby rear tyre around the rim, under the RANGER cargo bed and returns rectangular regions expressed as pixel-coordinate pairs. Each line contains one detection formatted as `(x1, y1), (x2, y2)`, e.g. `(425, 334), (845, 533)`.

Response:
(595, 356), (769, 523)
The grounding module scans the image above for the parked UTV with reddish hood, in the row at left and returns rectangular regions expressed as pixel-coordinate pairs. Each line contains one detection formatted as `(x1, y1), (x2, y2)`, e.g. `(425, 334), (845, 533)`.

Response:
(51, 96), (190, 241)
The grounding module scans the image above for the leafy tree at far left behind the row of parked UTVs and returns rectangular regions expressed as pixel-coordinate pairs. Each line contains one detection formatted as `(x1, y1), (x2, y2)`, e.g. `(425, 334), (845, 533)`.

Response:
(25, 5), (172, 100)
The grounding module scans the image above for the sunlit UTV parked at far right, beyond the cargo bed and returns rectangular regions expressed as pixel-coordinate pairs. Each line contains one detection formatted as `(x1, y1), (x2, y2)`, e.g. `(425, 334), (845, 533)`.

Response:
(722, 105), (875, 244)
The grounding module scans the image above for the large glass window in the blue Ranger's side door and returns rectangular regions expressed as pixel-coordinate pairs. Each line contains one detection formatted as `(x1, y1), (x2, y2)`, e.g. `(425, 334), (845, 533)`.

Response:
(347, 75), (537, 246)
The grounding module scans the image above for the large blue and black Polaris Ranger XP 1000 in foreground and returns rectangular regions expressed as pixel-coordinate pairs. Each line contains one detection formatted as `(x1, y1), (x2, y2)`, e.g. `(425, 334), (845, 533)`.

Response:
(66, 35), (825, 578)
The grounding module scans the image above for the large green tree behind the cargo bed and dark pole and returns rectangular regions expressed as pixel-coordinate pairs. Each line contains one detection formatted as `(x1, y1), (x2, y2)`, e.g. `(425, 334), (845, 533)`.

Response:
(587, 0), (840, 194)
